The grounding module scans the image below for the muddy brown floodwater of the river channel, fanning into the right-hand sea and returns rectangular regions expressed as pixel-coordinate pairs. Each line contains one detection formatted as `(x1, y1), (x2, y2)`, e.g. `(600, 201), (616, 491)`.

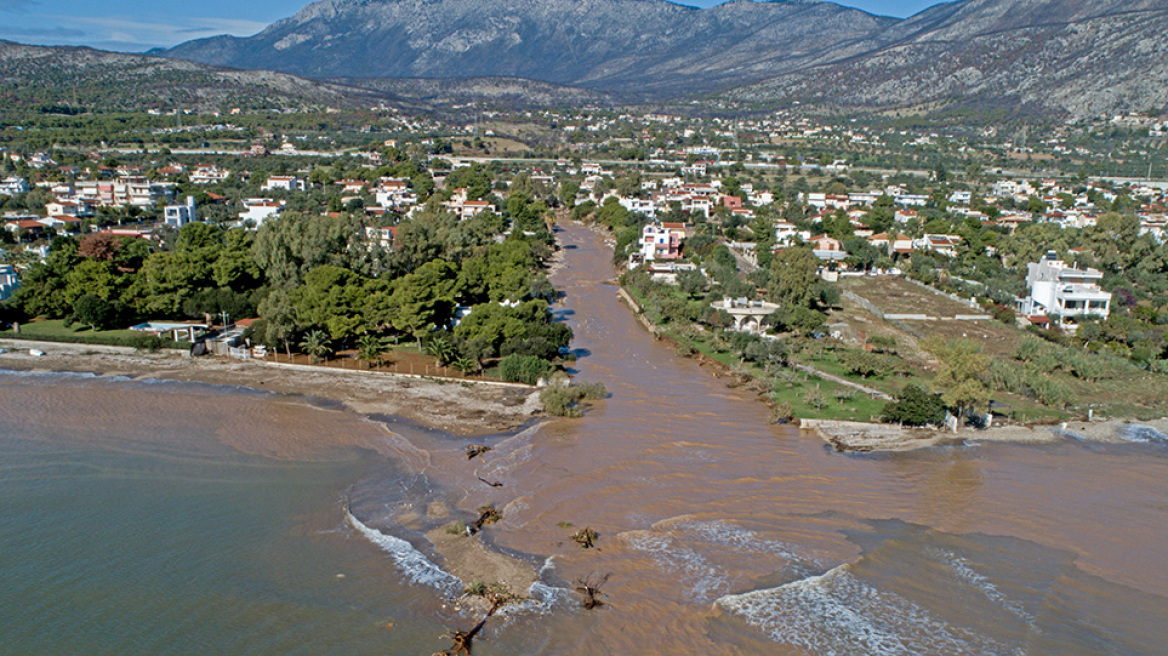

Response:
(329, 218), (1168, 654)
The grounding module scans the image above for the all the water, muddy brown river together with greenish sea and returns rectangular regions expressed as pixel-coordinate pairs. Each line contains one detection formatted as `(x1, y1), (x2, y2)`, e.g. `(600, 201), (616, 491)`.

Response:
(0, 224), (1168, 655)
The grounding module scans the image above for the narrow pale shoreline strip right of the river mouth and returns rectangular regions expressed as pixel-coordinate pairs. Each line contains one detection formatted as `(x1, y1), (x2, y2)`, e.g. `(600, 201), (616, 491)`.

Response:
(800, 419), (1168, 453)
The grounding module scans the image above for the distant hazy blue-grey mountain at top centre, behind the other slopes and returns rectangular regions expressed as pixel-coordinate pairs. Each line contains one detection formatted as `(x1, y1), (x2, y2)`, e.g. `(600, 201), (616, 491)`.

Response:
(160, 0), (898, 97)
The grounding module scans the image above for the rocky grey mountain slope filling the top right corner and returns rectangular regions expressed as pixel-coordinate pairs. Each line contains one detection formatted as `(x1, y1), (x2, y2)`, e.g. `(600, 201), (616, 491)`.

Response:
(729, 0), (1168, 120)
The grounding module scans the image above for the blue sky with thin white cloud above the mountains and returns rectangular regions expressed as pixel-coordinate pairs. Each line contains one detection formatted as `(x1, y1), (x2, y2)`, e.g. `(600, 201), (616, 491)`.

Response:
(0, 0), (938, 53)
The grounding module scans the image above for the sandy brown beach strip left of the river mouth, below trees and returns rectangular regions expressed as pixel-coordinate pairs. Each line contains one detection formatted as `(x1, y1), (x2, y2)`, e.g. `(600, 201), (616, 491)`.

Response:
(0, 340), (542, 437)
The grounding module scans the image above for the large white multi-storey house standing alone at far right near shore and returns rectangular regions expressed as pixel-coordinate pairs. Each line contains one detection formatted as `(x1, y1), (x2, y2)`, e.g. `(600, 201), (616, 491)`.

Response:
(1020, 251), (1111, 324)
